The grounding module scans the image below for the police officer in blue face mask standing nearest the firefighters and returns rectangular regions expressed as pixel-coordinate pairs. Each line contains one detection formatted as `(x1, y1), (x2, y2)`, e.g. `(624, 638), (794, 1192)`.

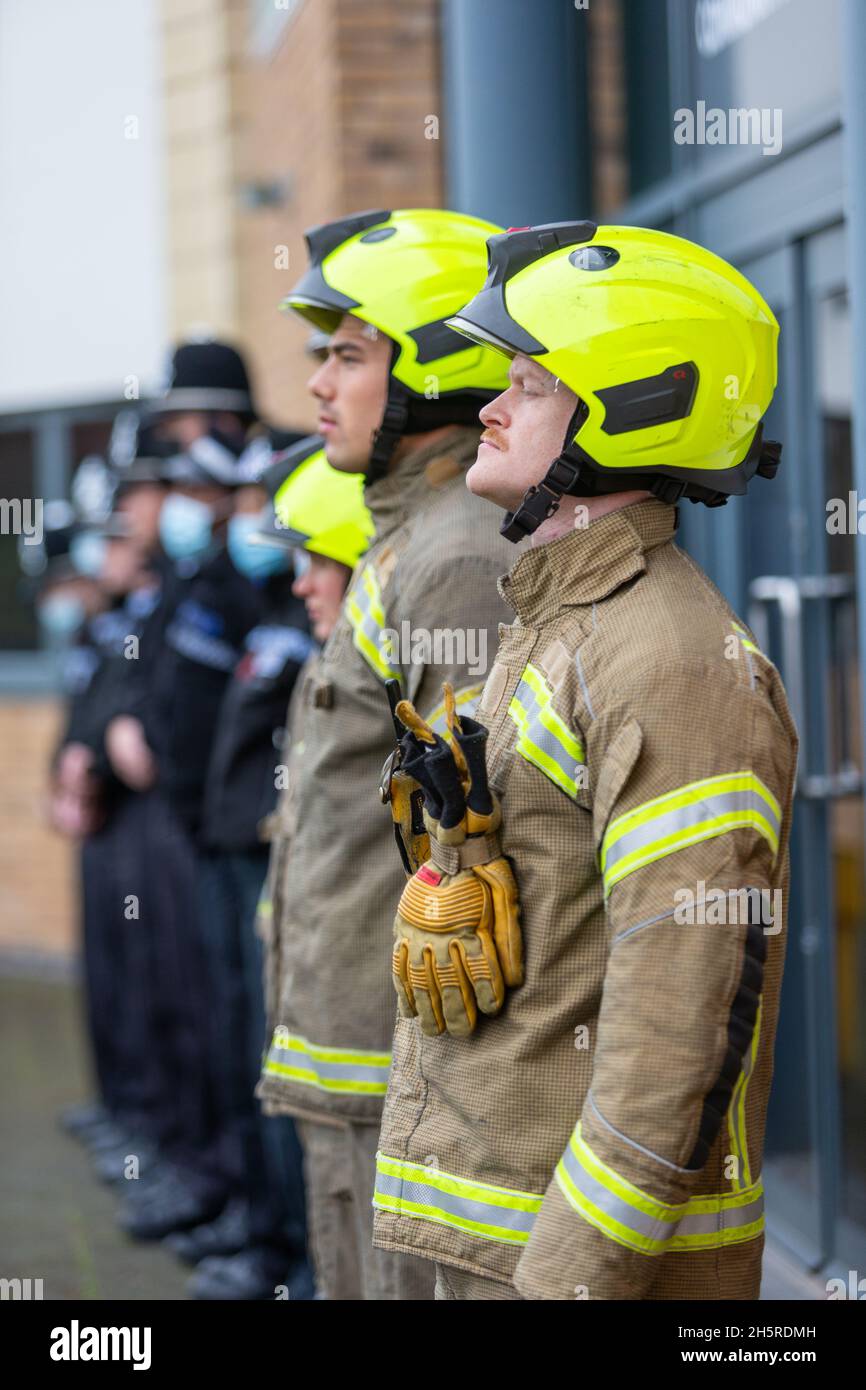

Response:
(179, 432), (318, 1298)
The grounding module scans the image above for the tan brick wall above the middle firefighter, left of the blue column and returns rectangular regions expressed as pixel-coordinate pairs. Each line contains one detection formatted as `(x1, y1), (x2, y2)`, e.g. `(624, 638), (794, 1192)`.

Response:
(228, 0), (442, 428)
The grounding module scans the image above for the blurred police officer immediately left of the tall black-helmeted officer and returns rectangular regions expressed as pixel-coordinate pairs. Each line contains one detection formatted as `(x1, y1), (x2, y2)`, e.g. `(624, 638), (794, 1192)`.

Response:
(72, 425), (170, 1182)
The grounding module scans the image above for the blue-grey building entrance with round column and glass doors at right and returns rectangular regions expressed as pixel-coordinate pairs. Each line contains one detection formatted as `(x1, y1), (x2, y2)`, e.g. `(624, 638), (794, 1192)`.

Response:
(442, 0), (866, 1273)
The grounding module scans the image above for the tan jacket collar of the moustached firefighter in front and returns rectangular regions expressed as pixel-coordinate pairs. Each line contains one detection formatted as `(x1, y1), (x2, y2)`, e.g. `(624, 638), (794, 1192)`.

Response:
(499, 498), (677, 627)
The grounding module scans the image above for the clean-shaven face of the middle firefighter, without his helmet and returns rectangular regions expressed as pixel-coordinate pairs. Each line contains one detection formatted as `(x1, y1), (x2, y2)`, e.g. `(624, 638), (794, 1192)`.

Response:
(307, 314), (392, 473)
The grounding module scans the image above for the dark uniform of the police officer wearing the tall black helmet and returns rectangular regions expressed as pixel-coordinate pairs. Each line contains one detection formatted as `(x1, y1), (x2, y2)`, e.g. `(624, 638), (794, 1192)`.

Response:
(114, 549), (261, 1236)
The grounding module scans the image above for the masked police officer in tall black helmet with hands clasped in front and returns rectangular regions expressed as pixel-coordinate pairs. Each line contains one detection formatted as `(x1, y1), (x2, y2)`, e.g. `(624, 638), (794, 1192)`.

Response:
(106, 342), (268, 1238)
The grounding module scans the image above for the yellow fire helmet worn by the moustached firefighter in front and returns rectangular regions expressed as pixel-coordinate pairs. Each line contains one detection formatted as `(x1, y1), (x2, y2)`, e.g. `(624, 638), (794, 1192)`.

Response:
(448, 222), (781, 541)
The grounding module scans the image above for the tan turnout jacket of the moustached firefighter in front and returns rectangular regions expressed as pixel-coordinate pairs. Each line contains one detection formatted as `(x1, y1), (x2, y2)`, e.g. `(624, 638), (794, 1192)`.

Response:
(374, 500), (796, 1298)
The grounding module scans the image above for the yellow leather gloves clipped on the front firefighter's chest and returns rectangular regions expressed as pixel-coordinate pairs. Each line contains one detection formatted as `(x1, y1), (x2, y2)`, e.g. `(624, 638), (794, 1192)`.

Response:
(393, 685), (523, 1037)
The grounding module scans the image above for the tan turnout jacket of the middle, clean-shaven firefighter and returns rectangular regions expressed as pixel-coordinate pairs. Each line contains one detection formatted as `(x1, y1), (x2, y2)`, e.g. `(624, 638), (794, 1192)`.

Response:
(257, 428), (513, 1125)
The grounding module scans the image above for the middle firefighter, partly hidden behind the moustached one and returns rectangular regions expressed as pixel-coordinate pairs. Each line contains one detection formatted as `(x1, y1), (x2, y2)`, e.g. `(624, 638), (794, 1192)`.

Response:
(259, 210), (509, 1300)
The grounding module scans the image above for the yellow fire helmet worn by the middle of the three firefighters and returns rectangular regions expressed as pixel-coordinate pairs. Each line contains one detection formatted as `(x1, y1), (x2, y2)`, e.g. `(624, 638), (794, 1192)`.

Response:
(279, 207), (507, 482)
